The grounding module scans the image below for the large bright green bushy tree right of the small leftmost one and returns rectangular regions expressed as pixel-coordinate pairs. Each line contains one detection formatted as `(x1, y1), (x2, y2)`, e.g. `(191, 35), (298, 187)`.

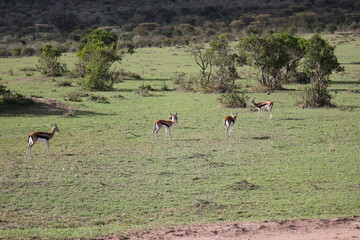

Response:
(77, 30), (134, 90)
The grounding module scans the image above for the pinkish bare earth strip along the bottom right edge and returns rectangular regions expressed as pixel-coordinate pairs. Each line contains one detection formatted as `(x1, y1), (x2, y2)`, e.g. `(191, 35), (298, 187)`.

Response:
(110, 217), (360, 240)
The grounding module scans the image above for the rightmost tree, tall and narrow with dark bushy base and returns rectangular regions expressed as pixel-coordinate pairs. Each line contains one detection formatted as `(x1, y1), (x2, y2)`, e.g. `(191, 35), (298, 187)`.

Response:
(302, 34), (344, 107)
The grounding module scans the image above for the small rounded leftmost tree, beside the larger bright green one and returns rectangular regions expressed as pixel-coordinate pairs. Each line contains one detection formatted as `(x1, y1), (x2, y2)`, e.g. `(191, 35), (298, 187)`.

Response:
(37, 45), (66, 76)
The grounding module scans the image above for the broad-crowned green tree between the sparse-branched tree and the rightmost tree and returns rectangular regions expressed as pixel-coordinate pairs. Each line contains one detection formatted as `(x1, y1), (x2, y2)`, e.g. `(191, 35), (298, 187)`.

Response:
(238, 33), (306, 90)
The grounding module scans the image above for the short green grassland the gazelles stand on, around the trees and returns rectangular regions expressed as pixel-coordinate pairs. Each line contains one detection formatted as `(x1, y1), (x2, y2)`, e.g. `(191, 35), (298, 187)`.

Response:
(0, 35), (360, 239)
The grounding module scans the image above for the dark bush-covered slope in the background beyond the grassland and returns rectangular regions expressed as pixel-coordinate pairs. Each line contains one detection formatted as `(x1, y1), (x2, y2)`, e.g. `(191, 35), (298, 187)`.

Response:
(0, 0), (360, 57)
